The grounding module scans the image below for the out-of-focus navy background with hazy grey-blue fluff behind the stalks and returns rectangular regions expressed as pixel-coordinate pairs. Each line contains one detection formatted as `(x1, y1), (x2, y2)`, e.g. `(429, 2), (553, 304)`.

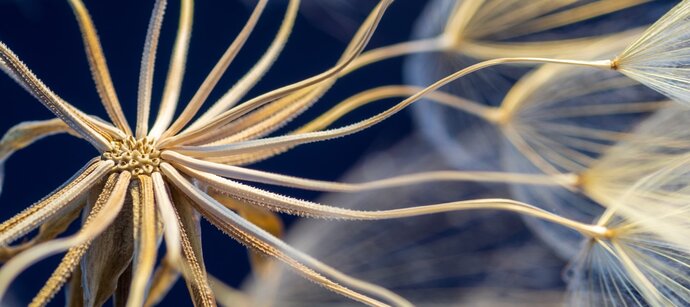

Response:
(0, 0), (675, 306)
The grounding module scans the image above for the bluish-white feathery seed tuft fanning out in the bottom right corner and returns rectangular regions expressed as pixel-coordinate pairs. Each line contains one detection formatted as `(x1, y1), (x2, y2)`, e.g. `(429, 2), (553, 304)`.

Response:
(568, 211), (690, 307)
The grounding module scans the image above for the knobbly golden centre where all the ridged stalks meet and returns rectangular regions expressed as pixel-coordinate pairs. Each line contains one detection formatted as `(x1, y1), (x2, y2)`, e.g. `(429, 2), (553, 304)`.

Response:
(101, 136), (161, 176)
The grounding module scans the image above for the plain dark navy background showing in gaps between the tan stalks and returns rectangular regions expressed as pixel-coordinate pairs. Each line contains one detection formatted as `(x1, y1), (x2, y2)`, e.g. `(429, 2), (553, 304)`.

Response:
(0, 0), (426, 306)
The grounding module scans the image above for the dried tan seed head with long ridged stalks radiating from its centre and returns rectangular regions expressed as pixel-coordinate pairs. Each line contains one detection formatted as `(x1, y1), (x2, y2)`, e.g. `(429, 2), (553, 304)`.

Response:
(0, 0), (684, 306)
